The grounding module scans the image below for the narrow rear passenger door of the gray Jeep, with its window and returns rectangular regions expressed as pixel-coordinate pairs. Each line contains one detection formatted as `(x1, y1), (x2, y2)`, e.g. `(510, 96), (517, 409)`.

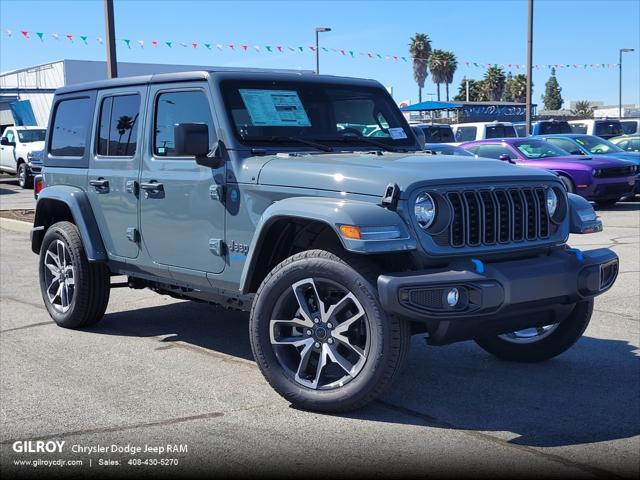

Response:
(87, 86), (147, 260)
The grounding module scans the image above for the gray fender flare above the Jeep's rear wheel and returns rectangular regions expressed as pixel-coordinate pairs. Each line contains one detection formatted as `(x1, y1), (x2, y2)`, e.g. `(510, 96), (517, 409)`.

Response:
(31, 185), (108, 262)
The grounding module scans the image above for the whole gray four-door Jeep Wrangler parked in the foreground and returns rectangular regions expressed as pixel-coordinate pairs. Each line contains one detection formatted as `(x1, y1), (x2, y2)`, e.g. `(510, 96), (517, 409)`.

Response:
(32, 69), (618, 412)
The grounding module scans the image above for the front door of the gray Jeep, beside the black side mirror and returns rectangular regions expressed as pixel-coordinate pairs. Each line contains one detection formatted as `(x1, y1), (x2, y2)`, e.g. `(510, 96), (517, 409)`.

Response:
(140, 82), (225, 278)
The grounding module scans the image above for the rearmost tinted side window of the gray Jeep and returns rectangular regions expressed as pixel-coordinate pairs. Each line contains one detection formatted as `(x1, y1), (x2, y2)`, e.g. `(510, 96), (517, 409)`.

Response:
(50, 98), (91, 157)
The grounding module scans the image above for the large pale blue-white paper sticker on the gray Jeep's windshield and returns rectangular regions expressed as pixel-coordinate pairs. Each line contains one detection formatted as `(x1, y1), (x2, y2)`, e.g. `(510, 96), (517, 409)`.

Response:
(239, 89), (311, 127)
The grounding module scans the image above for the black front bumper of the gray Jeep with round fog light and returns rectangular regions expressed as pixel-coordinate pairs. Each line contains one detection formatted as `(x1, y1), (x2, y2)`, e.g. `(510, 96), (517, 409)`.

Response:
(378, 248), (618, 344)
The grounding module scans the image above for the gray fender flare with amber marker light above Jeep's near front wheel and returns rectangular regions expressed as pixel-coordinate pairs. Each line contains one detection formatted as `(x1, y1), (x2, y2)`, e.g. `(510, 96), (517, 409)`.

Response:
(240, 197), (417, 293)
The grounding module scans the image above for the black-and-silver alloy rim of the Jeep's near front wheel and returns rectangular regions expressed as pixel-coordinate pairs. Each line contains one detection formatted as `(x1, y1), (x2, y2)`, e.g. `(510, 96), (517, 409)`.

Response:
(269, 278), (370, 390)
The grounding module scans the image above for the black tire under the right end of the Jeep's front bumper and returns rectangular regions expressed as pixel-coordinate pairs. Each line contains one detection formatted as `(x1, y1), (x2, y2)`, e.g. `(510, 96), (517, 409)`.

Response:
(476, 300), (593, 363)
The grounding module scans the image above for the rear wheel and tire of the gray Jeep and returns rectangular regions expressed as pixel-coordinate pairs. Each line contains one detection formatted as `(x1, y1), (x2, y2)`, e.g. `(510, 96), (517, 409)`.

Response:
(39, 222), (111, 328)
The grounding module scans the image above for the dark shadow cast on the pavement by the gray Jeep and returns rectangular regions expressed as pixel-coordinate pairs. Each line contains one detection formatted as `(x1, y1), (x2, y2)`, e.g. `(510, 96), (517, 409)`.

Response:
(89, 302), (640, 447)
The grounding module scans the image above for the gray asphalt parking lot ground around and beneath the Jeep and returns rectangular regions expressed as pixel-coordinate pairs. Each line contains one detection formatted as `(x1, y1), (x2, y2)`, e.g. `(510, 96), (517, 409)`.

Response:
(0, 177), (640, 478)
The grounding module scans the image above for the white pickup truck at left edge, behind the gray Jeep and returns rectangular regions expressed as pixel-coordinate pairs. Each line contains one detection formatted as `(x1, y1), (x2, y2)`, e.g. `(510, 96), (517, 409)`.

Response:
(0, 127), (47, 188)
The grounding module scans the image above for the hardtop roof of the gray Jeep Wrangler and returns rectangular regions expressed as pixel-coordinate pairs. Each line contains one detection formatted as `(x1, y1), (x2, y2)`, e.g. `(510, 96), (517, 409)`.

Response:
(55, 69), (382, 95)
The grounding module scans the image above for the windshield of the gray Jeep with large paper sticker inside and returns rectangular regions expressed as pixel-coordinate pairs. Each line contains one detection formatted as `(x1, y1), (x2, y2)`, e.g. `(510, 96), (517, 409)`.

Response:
(221, 80), (416, 148)
